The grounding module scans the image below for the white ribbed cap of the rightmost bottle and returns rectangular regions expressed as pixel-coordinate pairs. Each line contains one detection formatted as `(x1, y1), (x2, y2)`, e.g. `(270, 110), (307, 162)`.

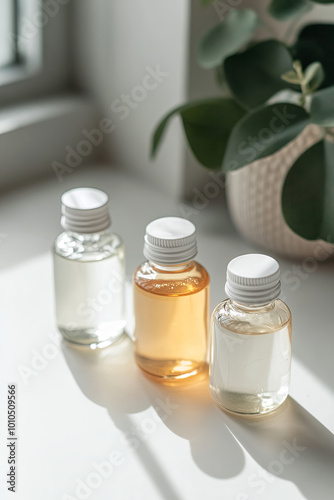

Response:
(225, 253), (281, 305)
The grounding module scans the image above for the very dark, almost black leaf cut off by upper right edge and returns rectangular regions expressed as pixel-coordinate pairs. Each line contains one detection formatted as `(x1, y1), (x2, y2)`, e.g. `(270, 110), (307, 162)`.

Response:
(291, 24), (334, 88)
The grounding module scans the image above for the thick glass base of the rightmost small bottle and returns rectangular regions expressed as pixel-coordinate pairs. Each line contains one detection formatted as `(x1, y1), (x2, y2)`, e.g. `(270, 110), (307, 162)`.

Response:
(210, 387), (288, 416)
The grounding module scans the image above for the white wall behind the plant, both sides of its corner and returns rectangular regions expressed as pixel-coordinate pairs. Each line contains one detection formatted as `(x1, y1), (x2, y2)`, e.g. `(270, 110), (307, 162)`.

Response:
(72, 0), (334, 197)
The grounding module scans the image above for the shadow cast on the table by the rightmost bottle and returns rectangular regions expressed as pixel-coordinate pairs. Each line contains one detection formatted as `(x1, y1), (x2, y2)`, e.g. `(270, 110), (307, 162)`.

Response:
(217, 397), (334, 500)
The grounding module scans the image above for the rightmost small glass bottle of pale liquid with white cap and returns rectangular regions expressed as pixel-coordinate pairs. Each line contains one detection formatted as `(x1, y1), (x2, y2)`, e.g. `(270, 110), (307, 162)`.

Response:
(210, 254), (291, 415)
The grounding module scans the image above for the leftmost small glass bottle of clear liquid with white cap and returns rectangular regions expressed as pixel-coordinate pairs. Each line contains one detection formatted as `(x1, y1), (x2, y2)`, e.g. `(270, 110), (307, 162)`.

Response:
(53, 188), (125, 348)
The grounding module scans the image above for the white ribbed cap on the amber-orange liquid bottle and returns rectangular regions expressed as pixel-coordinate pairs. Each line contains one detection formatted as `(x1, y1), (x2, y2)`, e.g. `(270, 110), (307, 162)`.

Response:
(144, 217), (197, 265)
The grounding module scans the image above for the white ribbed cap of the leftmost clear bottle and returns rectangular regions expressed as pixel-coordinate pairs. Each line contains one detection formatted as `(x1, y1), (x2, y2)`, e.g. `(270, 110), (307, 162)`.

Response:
(60, 188), (111, 233)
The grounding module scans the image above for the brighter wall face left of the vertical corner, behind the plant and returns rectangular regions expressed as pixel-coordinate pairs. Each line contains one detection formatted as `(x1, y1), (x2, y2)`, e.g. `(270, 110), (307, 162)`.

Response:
(72, 0), (190, 196)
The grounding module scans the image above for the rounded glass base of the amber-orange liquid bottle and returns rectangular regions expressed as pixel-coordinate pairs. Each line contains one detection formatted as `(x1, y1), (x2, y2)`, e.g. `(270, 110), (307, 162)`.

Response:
(135, 354), (208, 385)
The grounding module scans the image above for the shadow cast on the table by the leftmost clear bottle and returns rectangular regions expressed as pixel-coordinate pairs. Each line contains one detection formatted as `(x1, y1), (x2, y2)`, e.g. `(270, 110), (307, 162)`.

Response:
(61, 335), (189, 500)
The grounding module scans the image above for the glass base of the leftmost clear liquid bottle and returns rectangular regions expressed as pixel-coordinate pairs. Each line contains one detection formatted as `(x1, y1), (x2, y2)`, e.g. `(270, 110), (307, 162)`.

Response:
(58, 326), (125, 349)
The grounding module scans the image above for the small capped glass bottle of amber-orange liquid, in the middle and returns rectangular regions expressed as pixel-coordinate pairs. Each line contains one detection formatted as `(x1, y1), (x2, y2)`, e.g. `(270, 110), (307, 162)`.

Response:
(134, 217), (210, 384)
